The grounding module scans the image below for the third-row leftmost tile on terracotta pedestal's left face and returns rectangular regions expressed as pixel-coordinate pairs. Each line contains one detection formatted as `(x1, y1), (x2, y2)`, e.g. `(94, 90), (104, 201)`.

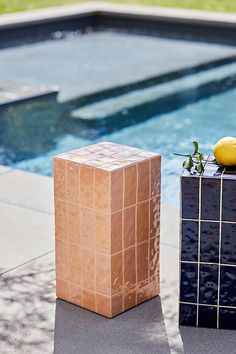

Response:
(56, 240), (68, 280)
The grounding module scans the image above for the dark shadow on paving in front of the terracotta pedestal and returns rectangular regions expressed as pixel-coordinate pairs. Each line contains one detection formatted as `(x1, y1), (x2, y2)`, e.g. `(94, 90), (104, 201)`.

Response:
(54, 297), (170, 354)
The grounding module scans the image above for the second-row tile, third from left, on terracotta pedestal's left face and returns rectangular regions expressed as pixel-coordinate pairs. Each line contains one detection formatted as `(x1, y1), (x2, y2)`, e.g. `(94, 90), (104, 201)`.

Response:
(80, 208), (95, 250)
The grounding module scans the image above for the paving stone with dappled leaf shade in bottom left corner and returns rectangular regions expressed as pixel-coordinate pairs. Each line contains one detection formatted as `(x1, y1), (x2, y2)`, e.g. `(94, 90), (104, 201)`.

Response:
(0, 255), (55, 354)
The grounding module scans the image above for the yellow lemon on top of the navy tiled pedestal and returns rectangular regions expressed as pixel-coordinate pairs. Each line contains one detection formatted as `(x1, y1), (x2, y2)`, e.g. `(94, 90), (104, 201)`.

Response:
(214, 136), (236, 166)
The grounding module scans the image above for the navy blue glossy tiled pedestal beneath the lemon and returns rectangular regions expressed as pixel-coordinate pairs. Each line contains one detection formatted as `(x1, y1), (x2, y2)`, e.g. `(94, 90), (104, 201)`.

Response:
(179, 158), (236, 329)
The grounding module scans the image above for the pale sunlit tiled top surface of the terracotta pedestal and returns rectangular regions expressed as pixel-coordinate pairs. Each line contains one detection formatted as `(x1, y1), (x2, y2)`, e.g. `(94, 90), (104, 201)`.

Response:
(55, 142), (160, 171)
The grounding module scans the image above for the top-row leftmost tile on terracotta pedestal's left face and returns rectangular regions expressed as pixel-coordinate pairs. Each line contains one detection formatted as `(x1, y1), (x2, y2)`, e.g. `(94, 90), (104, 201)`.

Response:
(54, 158), (66, 200)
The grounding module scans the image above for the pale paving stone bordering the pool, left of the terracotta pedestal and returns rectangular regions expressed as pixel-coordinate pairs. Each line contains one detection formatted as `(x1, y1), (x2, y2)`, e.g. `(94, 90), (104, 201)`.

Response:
(0, 170), (54, 214)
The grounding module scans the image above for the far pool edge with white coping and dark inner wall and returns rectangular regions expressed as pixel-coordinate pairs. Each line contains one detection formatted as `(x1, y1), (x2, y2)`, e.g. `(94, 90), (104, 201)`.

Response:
(0, 2), (236, 48)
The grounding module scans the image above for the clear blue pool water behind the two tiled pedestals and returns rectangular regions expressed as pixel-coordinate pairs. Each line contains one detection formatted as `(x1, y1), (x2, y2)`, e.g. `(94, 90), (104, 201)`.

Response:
(0, 32), (236, 205)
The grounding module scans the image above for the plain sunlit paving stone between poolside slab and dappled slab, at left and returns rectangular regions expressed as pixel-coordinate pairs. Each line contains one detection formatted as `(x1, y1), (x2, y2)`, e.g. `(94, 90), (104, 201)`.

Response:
(0, 202), (54, 274)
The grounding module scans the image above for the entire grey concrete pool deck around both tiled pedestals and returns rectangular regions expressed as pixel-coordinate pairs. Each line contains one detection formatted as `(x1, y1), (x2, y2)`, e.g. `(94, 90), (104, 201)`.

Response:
(0, 166), (236, 354)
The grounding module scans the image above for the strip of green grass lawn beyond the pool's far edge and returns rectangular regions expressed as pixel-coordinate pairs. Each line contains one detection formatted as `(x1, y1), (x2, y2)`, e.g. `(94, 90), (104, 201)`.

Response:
(0, 0), (236, 14)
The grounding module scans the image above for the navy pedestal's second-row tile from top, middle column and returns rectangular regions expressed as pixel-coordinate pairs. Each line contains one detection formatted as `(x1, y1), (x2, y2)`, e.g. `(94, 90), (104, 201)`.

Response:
(200, 221), (220, 263)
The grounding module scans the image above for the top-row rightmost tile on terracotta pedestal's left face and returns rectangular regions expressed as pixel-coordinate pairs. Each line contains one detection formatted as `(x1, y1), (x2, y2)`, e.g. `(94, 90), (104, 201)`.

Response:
(95, 168), (111, 212)
